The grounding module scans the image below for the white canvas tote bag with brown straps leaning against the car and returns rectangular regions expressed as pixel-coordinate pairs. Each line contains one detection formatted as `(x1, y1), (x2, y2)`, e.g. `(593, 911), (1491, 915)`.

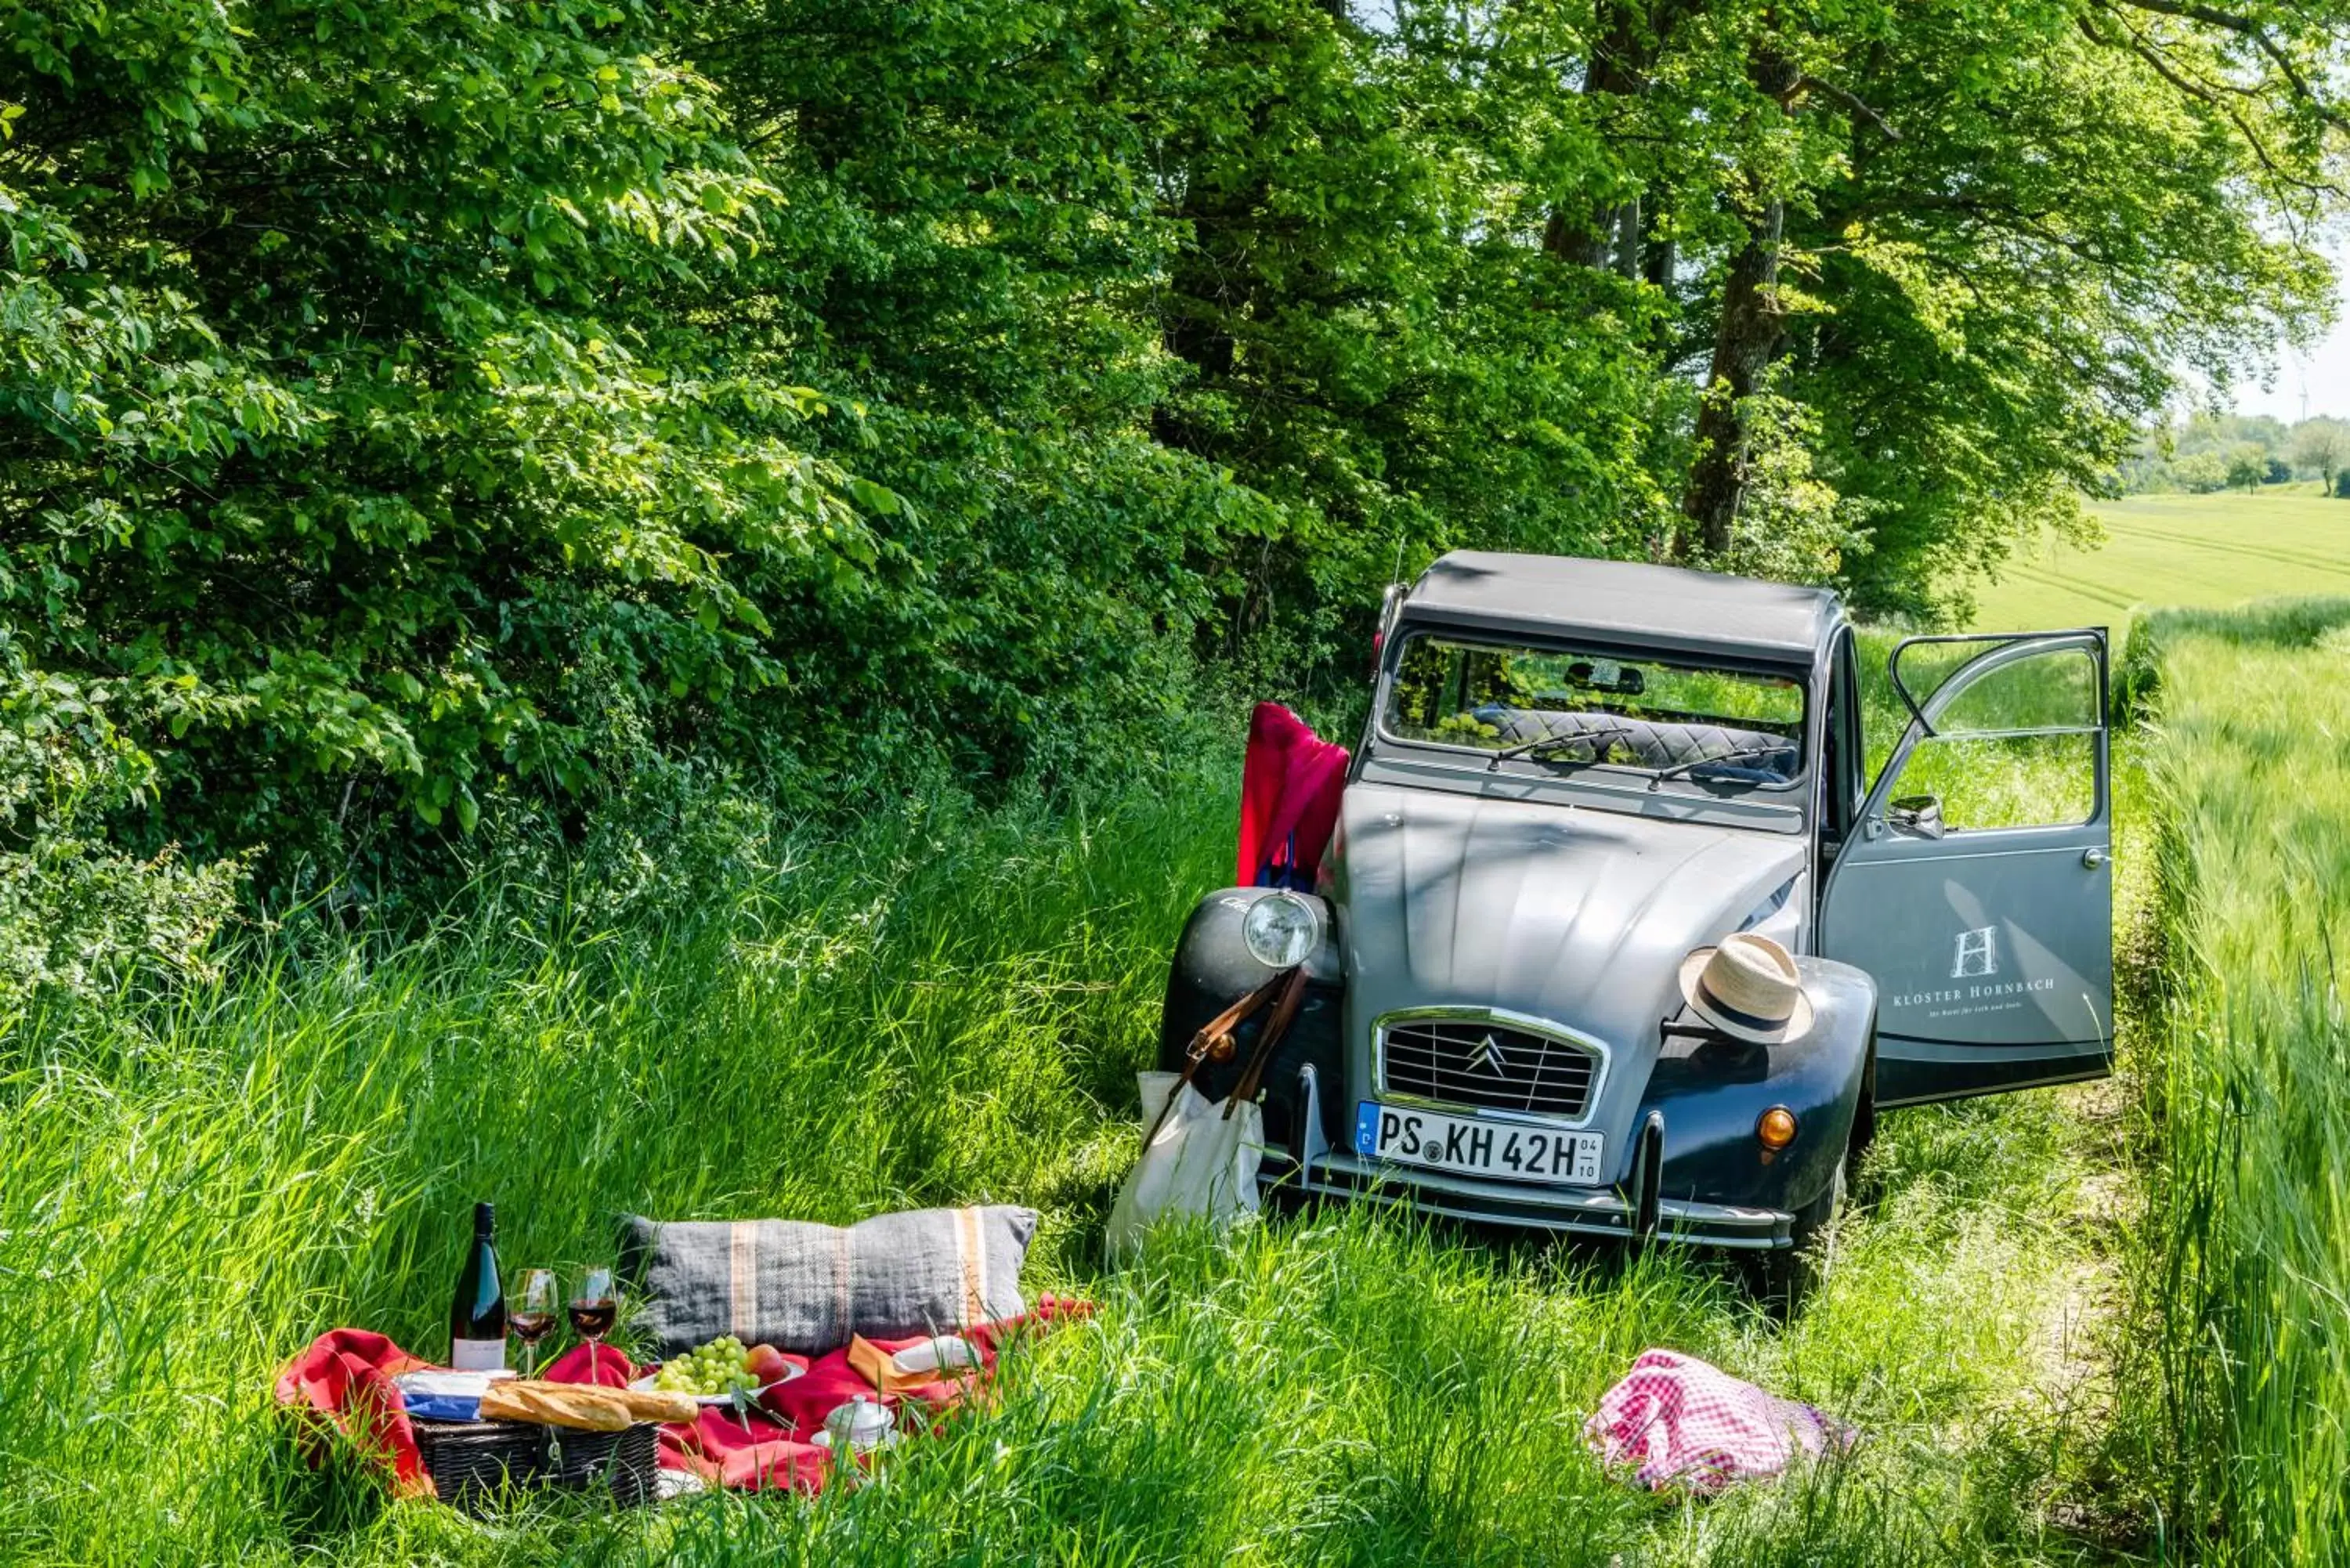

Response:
(1107, 966), (1307, 1258)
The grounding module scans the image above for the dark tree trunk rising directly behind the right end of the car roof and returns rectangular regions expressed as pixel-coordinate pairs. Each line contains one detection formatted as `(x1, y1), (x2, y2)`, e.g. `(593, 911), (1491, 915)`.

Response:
(1673, 56), (1795, 562)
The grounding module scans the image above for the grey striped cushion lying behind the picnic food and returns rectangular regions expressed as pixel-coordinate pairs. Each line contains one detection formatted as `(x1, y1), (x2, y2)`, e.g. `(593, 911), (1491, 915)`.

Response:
(620, 1204), (1036, 1357)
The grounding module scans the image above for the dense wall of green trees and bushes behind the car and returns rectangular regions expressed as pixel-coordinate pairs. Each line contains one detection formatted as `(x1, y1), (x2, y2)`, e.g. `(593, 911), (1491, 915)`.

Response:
(0, 0), (2345, 945)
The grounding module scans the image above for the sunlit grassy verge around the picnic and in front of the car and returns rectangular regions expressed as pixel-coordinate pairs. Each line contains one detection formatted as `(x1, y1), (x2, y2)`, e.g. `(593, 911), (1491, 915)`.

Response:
(0, 719), (2143, 1563)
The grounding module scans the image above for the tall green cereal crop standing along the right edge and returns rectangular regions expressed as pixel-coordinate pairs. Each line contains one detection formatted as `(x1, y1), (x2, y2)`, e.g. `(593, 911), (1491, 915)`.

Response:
(2131, 599), (2350, 1563)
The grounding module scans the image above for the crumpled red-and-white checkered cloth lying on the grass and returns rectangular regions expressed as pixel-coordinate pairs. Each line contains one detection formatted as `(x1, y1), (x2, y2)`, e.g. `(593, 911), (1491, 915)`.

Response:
(1584, 1349), (1861, 1493)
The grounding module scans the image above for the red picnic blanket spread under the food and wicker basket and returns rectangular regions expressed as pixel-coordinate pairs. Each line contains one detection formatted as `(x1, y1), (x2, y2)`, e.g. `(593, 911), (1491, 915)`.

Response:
(277, 1295), (1093, 1498)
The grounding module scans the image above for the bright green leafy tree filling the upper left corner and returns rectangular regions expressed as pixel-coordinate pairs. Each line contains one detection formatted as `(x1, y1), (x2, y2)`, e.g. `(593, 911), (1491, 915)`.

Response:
(0, 0), (893, 860)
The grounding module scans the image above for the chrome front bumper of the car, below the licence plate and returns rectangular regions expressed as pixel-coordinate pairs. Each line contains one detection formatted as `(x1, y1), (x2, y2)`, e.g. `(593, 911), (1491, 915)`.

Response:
(1257, 1068), (1795, 1251)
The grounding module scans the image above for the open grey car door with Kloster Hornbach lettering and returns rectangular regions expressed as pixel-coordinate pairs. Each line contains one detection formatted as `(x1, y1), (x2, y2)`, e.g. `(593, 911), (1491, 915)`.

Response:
(1819, 630), (2113, 1105)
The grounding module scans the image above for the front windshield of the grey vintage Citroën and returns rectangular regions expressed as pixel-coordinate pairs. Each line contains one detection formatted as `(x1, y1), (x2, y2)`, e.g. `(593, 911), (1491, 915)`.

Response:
(1382, 632), (1802, 786)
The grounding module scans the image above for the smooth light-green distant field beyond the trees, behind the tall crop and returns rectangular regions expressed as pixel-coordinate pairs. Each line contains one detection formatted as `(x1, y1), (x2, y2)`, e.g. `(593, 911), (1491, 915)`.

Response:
(1974, 484), (2350, 632)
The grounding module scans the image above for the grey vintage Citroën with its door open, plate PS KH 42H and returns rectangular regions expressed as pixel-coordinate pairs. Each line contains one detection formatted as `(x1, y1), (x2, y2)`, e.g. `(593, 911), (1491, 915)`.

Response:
(1161, 552), (2113, 1270)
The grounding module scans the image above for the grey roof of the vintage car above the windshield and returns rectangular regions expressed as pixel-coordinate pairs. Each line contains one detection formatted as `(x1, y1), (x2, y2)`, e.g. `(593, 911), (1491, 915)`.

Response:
(1403, 550), (1842, 663)
